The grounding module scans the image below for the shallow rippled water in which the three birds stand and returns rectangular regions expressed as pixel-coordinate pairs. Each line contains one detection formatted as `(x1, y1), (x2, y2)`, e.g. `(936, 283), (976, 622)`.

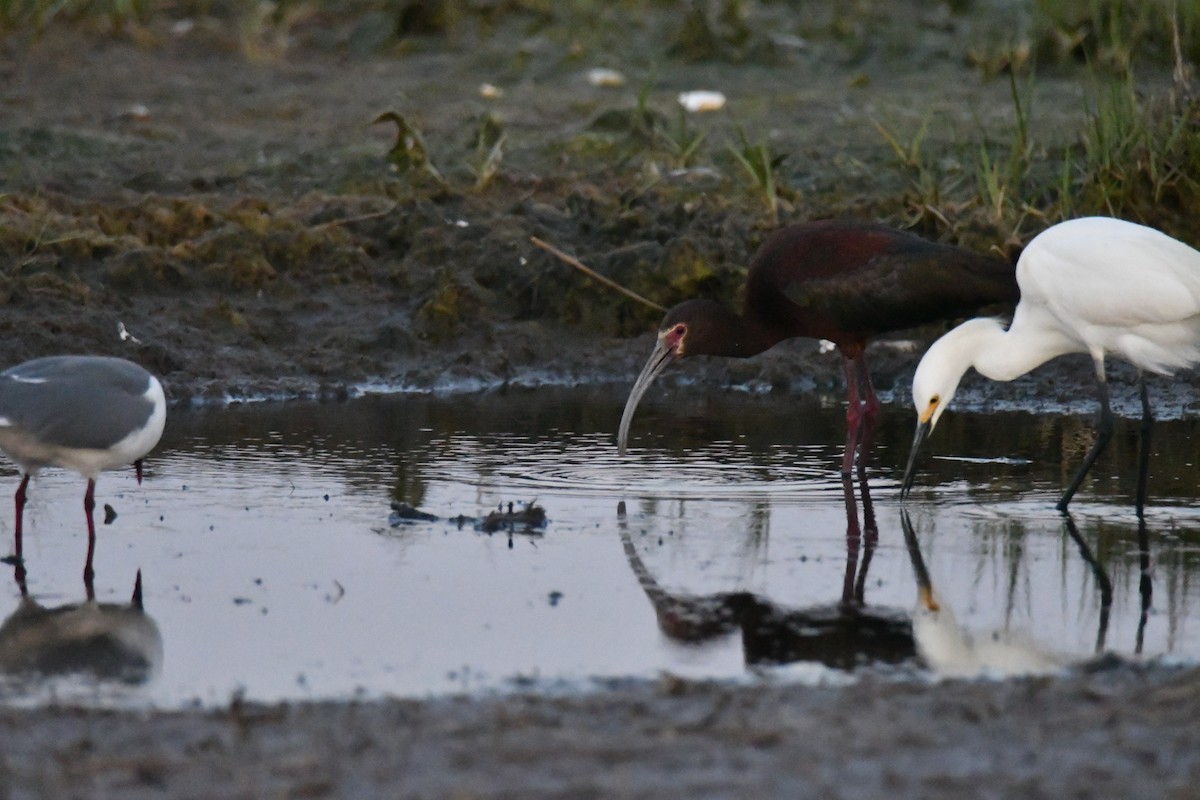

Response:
(0, 387), (1200, 708)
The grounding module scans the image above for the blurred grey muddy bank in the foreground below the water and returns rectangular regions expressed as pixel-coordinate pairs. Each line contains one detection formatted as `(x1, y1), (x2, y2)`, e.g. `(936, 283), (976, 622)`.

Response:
(0, 666), (1200, 800)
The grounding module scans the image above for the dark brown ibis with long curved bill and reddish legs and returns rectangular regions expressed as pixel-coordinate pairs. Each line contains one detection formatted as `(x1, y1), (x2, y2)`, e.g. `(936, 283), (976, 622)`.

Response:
(617, 219), (1019, 474)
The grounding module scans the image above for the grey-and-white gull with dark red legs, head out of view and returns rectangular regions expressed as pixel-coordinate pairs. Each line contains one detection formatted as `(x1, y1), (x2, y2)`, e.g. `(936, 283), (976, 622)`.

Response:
(0, 355), (167, 578)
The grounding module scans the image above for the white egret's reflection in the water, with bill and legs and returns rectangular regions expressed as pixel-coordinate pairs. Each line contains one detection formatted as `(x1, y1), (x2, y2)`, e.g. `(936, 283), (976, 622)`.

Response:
(900, 509), (1152, 678)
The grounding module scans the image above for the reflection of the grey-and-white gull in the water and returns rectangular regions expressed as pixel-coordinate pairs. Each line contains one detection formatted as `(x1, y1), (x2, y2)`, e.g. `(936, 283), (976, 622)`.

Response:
(0, 534), (162, 685)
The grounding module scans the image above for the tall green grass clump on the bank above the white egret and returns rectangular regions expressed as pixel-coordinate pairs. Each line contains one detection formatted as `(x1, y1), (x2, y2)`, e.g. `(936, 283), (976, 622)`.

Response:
(875, 50), (1200, 241)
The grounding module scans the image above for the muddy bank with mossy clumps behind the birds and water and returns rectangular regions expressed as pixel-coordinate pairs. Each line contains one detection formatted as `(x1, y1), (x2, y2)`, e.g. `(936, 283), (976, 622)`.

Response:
(0, 6), (1178, 405)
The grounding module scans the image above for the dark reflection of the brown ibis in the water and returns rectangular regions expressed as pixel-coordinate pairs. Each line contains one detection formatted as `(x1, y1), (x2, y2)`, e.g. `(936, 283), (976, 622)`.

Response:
(617, 476), (916, 669)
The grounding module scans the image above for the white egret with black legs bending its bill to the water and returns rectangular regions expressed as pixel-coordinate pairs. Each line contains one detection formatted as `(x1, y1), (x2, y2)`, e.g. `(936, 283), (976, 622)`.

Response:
(901, 217), (1200, 515)
